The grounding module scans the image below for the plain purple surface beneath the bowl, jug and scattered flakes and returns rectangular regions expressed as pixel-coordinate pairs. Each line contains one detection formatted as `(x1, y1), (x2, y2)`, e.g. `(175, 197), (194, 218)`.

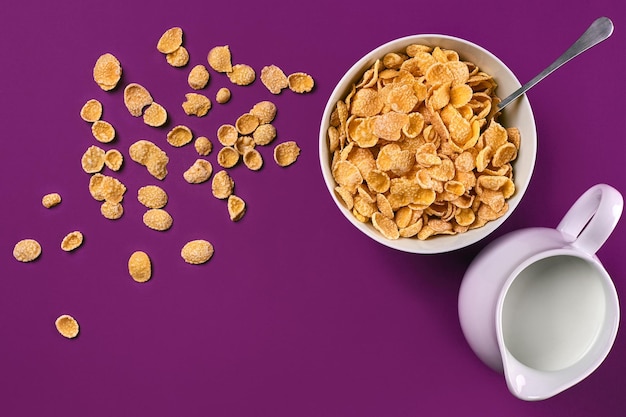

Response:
(0, 0), (626, 417)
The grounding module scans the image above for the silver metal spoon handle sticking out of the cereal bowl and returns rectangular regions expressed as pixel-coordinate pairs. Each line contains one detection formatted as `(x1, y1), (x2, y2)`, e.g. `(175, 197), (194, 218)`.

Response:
(498, 17), (613, 110)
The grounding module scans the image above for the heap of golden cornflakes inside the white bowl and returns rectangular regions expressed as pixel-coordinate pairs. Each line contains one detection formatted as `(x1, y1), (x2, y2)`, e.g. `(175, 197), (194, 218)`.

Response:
(328, 44), (521, 240)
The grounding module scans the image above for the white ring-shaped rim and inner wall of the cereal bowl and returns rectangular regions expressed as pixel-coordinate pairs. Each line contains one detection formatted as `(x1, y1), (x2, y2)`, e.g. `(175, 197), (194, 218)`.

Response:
(318, 33), (537, 254)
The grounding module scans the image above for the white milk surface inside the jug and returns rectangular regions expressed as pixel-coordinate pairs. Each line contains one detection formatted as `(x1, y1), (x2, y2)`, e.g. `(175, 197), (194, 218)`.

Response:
(502, 255), (606, 371)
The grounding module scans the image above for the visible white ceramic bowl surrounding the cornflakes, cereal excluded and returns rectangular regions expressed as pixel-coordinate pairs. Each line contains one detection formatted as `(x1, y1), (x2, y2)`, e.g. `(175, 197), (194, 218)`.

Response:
(319, 34), (537, 254)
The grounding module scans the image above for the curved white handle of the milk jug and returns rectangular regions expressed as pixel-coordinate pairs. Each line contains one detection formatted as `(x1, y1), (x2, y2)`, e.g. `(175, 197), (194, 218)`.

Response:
(557, 184), (624, 255)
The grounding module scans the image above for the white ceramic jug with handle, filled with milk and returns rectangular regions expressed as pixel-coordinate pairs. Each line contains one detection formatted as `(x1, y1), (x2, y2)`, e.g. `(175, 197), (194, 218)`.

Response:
(459, 184), (623, 400)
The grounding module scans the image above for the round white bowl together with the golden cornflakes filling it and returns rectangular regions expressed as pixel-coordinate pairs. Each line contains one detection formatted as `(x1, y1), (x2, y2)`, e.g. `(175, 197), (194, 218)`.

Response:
(319, 34), (537, 254)
